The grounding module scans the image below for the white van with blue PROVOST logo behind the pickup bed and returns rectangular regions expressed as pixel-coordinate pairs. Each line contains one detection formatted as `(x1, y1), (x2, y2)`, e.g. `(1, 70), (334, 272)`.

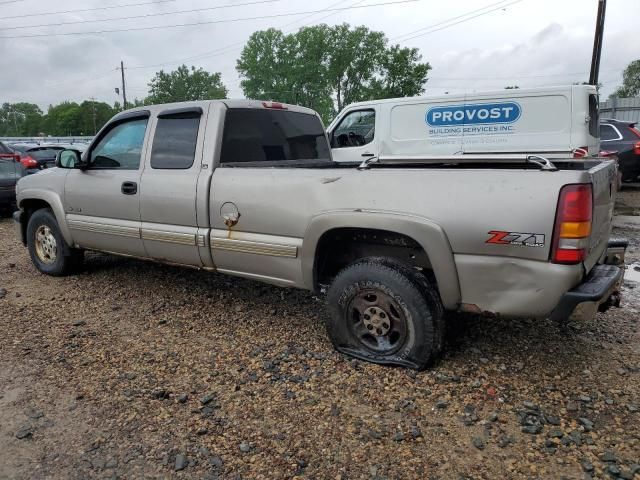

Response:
(327, 85), (600, 162)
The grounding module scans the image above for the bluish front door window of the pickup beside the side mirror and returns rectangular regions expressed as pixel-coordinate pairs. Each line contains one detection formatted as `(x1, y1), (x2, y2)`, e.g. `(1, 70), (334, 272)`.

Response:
(90, 118), (149, 170)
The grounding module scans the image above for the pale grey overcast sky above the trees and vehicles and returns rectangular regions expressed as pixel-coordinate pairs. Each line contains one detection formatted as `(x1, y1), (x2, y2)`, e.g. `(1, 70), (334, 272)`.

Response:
(0, 0), (640, 109)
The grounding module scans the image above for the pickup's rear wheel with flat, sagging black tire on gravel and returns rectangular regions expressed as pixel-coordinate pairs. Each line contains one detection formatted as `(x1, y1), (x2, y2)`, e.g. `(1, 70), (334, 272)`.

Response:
(327, 258), (444, 369)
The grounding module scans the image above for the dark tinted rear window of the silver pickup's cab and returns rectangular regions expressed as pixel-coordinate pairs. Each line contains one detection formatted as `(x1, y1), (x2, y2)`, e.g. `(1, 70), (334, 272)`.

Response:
(220, 108), (331, 164)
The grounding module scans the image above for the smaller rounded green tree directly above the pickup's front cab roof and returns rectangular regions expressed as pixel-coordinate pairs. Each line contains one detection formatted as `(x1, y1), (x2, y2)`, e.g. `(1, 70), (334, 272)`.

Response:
(144, 65), (227, 104)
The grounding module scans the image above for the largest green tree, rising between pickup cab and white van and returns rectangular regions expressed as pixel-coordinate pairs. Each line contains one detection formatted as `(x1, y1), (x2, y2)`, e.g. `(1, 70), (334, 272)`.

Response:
(236, 24), (431, 121)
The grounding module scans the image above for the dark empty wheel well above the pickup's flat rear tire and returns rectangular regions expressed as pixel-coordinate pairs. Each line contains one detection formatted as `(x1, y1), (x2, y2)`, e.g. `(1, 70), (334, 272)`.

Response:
(314, 228), (436, 288)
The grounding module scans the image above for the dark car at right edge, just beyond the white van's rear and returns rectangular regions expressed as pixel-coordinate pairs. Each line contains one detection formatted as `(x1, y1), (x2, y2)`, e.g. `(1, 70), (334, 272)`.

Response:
(600, 119), (640, 182)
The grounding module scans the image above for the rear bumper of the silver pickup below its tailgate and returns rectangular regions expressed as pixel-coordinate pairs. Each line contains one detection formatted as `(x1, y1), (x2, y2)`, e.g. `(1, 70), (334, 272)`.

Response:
(550, 239), (628, 320)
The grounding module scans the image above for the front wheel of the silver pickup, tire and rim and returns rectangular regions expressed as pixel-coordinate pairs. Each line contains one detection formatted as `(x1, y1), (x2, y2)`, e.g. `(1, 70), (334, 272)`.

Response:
(27, 209), (84, 277)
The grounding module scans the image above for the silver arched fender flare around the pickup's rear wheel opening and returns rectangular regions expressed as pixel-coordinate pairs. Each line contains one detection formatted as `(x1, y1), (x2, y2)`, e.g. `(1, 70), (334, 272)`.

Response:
(301, 210), (461, 310)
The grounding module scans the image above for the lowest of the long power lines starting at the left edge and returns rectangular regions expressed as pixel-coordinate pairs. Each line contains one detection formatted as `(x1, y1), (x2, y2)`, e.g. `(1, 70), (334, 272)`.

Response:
(0, 0), (422, 39)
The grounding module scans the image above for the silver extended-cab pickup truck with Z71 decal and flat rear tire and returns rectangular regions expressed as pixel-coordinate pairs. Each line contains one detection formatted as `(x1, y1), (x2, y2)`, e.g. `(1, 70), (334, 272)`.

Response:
(14, 100), (625, 368)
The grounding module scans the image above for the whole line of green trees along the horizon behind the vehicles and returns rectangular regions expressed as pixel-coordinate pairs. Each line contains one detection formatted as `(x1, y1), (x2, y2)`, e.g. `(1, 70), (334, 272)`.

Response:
(0, 24), (640, 136)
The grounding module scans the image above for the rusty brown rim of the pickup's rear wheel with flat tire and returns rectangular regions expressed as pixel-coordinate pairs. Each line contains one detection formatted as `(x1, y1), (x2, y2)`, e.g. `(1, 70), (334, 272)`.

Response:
(347, 290), (407, 355)
